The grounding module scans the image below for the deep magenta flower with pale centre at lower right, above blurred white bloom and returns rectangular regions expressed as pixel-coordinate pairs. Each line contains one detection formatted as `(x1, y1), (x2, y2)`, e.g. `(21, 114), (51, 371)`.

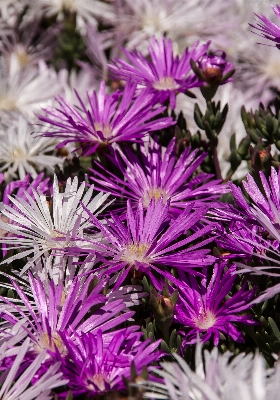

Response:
(174, 262), (256, 347)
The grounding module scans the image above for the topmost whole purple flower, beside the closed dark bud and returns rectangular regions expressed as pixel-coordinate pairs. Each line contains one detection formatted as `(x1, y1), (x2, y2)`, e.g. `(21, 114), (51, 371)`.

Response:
(109, 37), (210, 109)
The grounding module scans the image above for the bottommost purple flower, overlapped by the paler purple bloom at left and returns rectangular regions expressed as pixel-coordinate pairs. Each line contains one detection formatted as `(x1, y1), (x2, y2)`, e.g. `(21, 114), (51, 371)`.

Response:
(55, 329), (160, 396)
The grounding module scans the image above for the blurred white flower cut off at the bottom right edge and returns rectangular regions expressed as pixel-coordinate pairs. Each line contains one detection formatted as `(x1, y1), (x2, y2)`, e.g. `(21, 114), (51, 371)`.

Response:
(138, 343), (274, 400)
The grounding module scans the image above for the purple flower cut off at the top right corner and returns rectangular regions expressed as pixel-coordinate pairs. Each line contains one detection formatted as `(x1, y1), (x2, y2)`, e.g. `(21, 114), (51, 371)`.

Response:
(249, 5), (280, 49)
